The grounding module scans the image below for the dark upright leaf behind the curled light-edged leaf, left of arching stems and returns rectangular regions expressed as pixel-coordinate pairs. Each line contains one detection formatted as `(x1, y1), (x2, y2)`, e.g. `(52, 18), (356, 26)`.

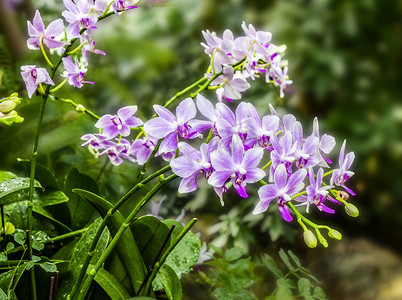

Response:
(64, 168), (99, 230)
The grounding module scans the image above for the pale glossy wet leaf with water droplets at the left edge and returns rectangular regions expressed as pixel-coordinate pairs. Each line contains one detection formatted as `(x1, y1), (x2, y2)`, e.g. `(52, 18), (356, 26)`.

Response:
(0, 177), (43, 205)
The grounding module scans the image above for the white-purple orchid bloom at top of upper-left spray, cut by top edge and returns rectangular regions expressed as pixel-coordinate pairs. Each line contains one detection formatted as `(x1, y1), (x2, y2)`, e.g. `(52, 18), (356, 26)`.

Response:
(62, 0), (98, 39)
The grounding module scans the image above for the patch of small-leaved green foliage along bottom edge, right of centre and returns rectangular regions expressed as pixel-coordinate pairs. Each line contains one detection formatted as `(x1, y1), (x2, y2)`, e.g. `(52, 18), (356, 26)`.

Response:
(199, 246), (327, 300)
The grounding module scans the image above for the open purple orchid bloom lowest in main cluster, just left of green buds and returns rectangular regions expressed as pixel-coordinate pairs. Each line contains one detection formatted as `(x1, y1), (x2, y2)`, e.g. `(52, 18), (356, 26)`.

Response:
(253, 164), (307, 222)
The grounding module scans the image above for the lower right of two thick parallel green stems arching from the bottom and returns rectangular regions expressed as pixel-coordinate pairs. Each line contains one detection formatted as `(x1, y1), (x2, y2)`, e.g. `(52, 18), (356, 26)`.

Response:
(78, 174), (177, 300)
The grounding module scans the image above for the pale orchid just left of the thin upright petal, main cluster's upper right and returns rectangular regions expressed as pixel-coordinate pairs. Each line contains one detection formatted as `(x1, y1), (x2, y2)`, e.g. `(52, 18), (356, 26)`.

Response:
(293, 122), (319, 169)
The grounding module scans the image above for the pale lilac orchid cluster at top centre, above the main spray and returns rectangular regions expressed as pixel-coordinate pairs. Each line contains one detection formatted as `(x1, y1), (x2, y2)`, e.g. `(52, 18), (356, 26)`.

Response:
(201, 22), (292, 101)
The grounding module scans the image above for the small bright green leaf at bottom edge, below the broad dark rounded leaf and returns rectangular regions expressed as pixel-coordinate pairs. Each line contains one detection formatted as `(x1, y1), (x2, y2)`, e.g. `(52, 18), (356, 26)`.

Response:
(152, 264), (182, 300)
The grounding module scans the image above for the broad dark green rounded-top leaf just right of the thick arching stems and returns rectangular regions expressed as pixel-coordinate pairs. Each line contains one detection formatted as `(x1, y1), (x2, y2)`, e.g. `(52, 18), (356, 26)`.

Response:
(131, 216), (170, 268)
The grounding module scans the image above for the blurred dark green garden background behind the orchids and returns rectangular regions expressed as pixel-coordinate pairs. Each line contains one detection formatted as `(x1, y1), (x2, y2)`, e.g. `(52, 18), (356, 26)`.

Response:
(0, 0), (402, 299)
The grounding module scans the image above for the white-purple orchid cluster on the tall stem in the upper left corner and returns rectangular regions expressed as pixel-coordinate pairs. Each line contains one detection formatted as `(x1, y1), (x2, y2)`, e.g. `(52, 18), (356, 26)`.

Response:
(21, 0), (138, 98)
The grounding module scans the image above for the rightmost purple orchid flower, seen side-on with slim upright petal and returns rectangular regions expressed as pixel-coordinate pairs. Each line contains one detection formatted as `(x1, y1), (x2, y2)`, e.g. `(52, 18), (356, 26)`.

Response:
(330, 140), (356, 196)
